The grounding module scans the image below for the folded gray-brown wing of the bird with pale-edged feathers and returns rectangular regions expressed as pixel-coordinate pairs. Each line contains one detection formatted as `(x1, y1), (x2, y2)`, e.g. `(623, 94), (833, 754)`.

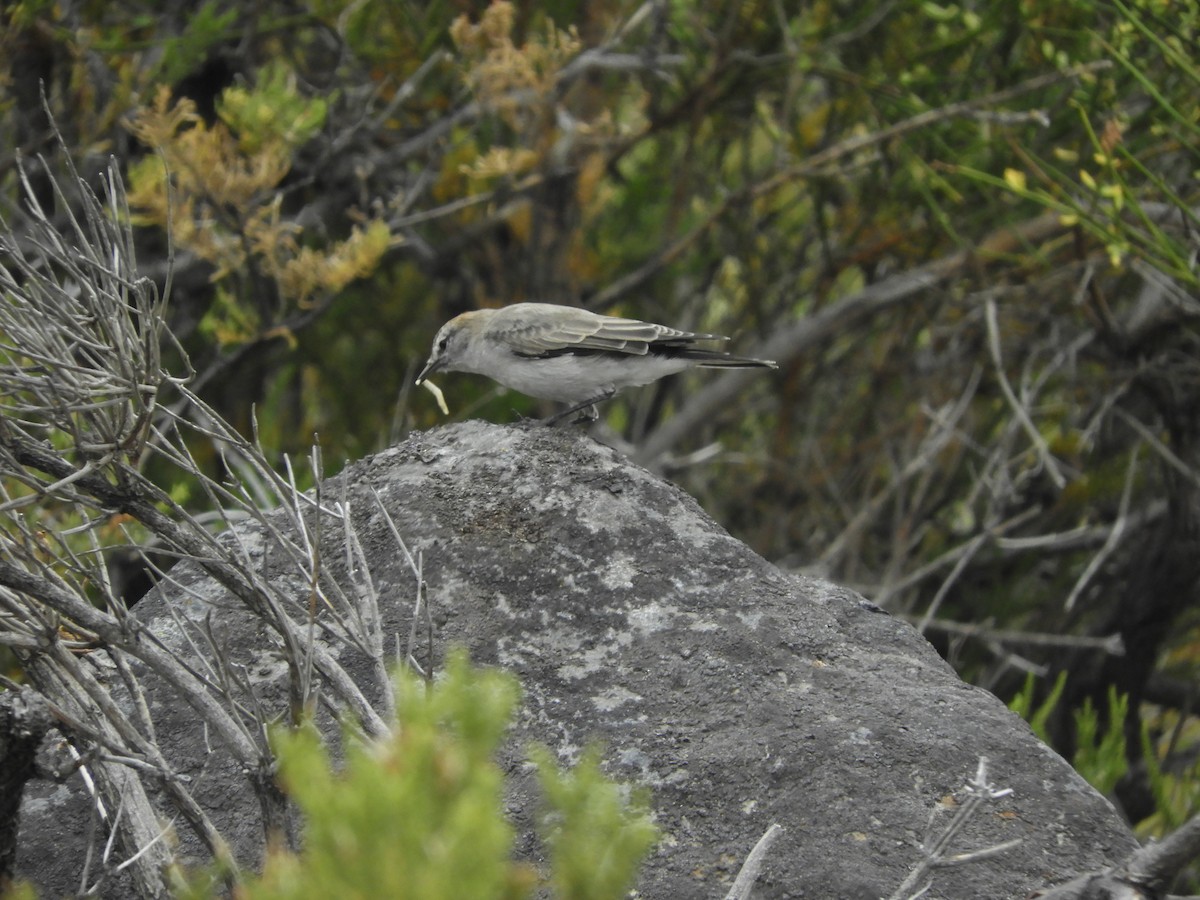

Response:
(497, 304), (724, 356)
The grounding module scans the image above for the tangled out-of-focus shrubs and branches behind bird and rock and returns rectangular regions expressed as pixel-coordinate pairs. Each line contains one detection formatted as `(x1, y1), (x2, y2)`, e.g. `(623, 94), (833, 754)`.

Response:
(0, 0), (1200, 888)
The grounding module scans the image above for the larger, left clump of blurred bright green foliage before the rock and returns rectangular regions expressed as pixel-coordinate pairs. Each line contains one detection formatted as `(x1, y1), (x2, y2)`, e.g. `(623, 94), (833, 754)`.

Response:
(240, 655), (532, 900)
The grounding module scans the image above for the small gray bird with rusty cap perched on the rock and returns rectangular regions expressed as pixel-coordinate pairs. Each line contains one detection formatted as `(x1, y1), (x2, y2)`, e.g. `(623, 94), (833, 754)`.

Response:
(416, 302), (779, 424)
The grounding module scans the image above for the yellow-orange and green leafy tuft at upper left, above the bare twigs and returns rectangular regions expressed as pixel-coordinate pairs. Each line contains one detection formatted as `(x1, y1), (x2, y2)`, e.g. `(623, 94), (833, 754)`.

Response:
(130, 64), (391, 343)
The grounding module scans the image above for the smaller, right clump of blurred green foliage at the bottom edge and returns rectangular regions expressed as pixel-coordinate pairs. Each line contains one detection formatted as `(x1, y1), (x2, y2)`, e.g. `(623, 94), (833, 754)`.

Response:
(534, 748), (658, 900)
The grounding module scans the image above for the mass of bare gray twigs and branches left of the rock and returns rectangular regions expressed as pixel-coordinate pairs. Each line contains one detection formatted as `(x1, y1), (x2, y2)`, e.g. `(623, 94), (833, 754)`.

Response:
(0, 148), (432, 896)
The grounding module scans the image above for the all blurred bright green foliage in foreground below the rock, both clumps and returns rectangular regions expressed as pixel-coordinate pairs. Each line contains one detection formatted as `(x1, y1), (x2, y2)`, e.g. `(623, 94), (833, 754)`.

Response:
(178, 654), (656, 900)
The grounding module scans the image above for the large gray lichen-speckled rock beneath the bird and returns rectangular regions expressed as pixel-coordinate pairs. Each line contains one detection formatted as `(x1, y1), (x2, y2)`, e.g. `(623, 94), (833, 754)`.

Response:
(20, 422), (1135, 900)
